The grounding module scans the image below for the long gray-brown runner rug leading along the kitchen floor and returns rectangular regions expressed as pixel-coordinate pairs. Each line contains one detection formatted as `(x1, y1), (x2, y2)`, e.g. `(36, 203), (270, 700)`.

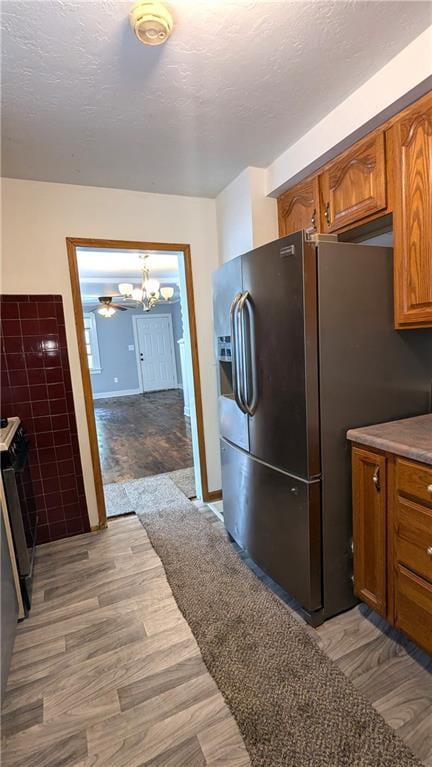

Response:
(138, 503), (421, 767)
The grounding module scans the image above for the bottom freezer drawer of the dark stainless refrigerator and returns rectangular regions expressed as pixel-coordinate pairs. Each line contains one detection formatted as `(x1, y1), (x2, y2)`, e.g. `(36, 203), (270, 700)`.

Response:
(221, 440), (322, 611)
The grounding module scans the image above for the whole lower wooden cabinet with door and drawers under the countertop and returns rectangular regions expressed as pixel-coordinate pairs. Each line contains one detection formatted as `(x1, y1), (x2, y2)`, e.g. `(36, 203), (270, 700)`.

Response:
(352, 445), (432, 653)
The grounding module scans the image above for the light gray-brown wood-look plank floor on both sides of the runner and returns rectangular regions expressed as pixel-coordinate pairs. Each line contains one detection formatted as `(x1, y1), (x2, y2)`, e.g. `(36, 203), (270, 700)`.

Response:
(2, 507), (432, 767)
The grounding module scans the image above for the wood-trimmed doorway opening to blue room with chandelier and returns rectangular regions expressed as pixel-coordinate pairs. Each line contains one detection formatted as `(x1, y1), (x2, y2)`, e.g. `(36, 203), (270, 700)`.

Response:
(67, 238), (208, 527)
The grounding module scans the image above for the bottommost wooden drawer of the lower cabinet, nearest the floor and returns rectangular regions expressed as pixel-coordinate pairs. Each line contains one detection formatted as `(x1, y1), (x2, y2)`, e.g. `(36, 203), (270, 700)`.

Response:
(394, 565), (432, 653)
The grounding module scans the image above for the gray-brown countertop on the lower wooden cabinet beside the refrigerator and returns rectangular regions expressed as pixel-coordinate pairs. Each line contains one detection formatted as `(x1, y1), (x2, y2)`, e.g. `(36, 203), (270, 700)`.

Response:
(347, 413), (432, 464)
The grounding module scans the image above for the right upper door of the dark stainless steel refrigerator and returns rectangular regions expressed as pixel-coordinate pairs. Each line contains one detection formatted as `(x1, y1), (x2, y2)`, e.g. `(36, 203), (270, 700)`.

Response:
(241, 232), (320, 478)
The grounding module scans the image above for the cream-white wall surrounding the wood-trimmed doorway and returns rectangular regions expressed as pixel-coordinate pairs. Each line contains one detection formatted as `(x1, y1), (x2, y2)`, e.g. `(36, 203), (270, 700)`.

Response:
(2, 179), (220, 525)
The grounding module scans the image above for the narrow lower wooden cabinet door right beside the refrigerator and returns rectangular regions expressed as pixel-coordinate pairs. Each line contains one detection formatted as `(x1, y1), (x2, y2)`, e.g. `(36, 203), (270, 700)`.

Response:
(352, 448), (387, 615)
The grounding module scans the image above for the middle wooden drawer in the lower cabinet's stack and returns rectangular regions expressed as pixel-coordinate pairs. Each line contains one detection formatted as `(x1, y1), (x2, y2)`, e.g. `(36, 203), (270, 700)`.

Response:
(395, 497), (432, 581)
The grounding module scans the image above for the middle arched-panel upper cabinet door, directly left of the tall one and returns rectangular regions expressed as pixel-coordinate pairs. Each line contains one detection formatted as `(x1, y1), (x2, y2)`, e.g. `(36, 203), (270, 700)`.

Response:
(319, 131), (387, 232)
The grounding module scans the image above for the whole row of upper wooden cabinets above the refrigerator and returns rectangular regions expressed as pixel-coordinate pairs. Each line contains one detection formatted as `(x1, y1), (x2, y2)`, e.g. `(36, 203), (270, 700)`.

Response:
(278, 92), (432, 329)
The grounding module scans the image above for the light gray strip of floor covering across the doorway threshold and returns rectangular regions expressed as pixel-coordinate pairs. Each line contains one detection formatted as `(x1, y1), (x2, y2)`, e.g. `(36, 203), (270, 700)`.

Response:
(104, 468), (195, 517)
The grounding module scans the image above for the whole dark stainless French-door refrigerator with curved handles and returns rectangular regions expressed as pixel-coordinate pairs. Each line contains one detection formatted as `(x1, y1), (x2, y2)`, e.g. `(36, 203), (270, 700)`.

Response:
(213, 232), (432, 625)
